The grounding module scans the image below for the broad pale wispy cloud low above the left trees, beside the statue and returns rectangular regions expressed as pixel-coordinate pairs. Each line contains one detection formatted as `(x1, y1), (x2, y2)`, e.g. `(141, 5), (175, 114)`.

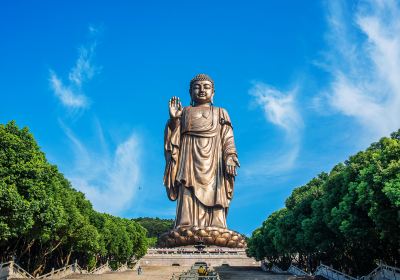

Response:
(61, 123), (141, 214)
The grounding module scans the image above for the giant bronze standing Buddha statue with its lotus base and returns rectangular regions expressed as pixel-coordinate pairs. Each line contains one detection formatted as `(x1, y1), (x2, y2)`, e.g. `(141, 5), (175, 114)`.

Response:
(160, 74), (245, 247)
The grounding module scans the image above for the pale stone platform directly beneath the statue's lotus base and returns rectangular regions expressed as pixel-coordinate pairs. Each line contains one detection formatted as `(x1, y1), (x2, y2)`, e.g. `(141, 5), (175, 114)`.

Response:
(139, 246), (261, 267)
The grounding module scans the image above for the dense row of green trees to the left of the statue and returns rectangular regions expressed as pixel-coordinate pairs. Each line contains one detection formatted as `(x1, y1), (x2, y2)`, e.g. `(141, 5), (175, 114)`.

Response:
(0, 122), (147, 274)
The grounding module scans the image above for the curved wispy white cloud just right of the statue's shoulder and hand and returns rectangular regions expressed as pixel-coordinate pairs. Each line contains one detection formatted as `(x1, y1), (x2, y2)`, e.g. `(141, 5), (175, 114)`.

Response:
(244, 82), (303, 177)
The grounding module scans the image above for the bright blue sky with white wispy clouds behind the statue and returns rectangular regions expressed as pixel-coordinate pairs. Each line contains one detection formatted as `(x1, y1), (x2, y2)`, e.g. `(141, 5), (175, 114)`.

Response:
(0, 0), (400, 234)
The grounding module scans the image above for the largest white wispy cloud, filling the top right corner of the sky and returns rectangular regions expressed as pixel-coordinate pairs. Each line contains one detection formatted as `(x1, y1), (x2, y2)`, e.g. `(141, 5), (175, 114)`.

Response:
(321, 0), (400, 141)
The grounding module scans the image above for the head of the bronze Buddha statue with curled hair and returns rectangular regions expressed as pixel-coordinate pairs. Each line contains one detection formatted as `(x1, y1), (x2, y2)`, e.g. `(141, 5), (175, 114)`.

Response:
(189, 74), (214, 105)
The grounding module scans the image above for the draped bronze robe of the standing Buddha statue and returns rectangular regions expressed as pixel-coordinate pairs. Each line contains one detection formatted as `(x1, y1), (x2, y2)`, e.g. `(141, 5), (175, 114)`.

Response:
(164, 106), (237, 228)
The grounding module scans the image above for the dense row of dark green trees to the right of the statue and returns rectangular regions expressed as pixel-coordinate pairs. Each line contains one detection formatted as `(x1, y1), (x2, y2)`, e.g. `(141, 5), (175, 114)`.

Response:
(248, 130), (400, 275)
